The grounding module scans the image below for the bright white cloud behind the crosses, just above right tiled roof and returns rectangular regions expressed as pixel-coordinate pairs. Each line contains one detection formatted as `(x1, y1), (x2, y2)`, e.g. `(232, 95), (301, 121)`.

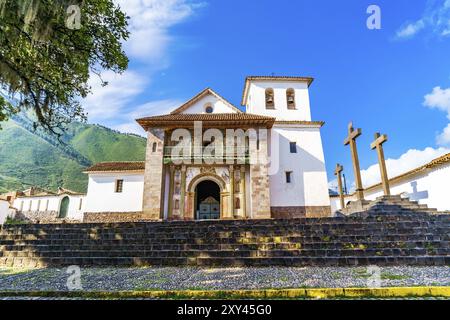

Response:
(361, 147), (450, 187)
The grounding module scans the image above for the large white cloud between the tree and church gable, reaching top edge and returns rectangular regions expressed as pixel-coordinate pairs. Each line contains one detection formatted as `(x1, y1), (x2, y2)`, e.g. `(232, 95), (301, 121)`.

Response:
(83, 0), (204, 127)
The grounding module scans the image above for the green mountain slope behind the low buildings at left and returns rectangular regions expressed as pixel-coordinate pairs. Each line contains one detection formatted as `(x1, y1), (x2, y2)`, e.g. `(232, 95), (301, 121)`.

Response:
(0, 115), (146, 193)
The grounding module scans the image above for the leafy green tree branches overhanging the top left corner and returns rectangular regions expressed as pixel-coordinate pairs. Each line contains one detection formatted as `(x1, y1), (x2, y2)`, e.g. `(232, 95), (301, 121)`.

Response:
(0, 0), (129, 135)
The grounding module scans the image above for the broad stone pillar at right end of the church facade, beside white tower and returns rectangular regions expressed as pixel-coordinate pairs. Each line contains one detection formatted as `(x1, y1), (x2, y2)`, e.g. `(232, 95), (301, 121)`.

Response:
(249, 128), (271, 219)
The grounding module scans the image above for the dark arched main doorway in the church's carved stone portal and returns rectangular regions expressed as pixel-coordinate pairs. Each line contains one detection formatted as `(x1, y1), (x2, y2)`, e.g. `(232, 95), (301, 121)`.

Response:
(194, 180), (220, 220)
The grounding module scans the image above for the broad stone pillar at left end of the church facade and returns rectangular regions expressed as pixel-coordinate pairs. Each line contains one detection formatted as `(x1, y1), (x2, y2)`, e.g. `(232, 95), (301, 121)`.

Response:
(142, 128), (164, 220)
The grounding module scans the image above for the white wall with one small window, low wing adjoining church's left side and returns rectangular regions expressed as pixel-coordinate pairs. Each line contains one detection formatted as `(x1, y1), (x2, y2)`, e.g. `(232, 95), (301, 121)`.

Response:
(85, 172), (144, 212)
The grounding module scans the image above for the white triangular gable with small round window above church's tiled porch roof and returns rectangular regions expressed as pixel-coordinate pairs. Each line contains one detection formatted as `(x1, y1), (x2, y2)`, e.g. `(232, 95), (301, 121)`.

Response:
(171, 88), (242, 114)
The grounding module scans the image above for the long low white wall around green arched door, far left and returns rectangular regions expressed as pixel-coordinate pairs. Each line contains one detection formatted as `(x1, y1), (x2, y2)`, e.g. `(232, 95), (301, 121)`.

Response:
(13, 194), (86, 220)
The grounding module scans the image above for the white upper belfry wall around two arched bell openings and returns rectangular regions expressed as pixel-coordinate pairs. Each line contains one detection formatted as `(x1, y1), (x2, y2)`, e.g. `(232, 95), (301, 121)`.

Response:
(246, 81), (311, 121)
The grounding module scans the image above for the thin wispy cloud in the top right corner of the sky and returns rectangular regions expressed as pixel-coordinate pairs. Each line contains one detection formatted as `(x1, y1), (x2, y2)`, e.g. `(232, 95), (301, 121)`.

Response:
(396, 0), (450, 39)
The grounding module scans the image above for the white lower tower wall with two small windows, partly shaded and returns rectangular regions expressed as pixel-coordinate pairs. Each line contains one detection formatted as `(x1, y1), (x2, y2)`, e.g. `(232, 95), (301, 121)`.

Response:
(269, 125), (330, 207)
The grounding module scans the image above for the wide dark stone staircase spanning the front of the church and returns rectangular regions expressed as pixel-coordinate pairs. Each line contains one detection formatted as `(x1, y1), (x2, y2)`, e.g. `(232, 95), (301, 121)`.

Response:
(0, 211), (450, 267)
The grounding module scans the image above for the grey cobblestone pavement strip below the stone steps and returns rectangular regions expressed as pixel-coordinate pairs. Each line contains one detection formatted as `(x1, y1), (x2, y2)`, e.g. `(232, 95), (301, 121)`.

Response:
(0, 266), (450, 291)
